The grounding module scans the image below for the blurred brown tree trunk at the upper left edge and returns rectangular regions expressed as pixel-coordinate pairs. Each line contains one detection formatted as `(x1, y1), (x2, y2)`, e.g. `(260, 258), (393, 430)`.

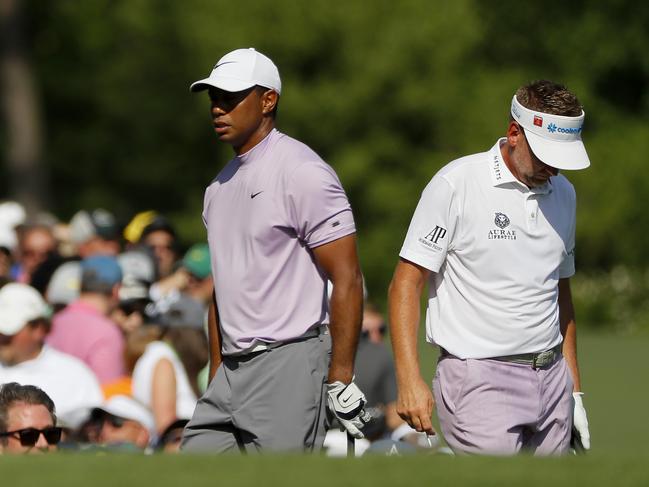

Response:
(0, 0), (48, 216)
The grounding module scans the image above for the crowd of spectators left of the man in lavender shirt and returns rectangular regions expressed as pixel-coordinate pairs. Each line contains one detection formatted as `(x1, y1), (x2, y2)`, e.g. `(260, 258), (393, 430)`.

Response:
(0, 202), (212, 453)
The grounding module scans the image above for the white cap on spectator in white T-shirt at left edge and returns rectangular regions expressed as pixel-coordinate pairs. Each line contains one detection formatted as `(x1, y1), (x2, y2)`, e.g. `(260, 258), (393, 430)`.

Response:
(0, 282), (50, 336)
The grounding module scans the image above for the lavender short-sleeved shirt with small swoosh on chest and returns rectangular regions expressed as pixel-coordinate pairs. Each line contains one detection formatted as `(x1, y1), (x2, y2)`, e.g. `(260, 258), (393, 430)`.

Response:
(203, 130), (356, 355)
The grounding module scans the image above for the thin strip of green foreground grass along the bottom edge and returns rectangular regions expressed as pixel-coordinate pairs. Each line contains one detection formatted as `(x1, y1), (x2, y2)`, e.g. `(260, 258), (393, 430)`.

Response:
(0, 453), (649, 487)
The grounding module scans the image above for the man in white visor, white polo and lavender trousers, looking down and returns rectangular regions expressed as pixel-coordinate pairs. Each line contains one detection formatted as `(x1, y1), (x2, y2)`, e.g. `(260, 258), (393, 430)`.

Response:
(389, 81), (590, 455)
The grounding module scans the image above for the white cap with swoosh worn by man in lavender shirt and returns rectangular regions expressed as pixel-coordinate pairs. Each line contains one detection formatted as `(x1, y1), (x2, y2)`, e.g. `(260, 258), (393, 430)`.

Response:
(189, 47), (282, 94)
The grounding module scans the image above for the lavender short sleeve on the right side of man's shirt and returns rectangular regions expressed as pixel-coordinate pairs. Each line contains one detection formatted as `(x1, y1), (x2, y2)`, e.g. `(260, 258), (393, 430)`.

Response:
(287, 161), (356, 248)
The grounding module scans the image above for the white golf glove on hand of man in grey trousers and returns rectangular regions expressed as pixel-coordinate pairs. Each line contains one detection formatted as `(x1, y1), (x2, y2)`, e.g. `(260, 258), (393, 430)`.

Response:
(327, 381), (371, 439)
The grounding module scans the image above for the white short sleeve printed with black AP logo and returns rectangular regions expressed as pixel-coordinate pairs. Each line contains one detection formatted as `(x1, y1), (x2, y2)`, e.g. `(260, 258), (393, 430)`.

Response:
(399, 175), (458, 272)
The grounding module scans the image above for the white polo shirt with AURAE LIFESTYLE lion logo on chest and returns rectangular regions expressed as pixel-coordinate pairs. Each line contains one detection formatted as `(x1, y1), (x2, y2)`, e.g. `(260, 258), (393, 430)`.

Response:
(399, 139), (576, 358)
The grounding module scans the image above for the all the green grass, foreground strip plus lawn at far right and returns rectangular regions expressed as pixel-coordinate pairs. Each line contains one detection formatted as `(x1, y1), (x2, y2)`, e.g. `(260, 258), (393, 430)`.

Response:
(0, 335), (649, 487)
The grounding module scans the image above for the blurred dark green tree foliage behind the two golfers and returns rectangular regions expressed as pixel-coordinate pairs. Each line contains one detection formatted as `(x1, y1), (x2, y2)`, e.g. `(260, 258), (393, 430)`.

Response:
(0, 0), (649, 303)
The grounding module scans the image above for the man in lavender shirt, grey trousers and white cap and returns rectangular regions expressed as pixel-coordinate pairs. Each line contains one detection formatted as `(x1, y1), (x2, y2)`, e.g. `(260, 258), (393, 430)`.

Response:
(182, 49), (366, 452)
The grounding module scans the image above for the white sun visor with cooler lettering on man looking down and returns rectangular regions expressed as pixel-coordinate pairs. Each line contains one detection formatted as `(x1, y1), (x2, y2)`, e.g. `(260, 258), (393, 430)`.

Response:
(511, 95), (590, 169)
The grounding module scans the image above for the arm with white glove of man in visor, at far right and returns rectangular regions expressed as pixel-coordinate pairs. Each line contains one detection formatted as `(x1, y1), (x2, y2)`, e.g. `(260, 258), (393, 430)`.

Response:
(559, 278), (590, 450)
